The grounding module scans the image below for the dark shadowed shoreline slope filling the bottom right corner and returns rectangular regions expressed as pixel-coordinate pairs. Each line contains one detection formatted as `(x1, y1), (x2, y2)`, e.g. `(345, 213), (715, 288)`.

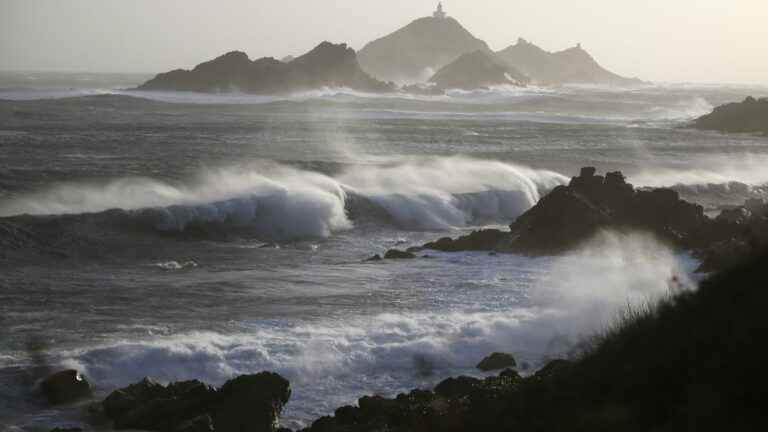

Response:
(307, 249), (768, 432)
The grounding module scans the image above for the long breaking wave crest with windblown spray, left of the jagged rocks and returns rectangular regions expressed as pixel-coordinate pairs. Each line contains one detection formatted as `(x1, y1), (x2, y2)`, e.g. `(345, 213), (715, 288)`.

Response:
(0, 158), (566, 239)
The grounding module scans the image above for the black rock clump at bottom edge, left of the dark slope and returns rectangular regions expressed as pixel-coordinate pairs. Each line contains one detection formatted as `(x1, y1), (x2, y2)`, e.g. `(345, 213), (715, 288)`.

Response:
(102, 372), (291, 432)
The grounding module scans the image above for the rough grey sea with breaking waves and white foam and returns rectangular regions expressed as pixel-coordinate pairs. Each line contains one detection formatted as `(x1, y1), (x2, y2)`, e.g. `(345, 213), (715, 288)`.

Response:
(0, 73), (768, 431)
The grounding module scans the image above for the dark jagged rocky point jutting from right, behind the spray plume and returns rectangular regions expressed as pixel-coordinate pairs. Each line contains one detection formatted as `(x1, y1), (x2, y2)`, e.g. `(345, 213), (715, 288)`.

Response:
(410, 167), (768, 271)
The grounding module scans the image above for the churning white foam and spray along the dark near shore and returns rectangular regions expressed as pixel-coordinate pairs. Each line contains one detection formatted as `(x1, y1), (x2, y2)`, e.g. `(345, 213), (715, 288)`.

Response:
(63, 232), (694, 426)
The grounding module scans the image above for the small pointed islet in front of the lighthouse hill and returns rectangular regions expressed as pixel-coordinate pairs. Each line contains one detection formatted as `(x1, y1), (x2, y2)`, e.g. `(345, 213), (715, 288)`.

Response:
(429, 50), (529, 90)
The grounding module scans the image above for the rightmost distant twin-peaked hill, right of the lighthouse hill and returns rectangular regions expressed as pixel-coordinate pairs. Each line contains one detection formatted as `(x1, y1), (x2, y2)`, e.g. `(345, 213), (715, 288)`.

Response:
(496, 38), (642, 86)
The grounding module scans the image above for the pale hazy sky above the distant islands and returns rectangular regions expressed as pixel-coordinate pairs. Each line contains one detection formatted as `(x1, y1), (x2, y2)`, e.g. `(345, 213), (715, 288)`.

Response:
(0, 0), (768, 84)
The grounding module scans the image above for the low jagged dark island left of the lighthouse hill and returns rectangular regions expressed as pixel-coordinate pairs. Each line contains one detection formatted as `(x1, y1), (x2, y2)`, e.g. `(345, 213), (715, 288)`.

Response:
(138, 42), (393, 94)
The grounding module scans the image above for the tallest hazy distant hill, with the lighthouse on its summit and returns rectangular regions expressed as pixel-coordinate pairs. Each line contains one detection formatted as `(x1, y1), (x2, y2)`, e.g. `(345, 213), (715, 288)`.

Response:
(358, 16), (490, 83)
